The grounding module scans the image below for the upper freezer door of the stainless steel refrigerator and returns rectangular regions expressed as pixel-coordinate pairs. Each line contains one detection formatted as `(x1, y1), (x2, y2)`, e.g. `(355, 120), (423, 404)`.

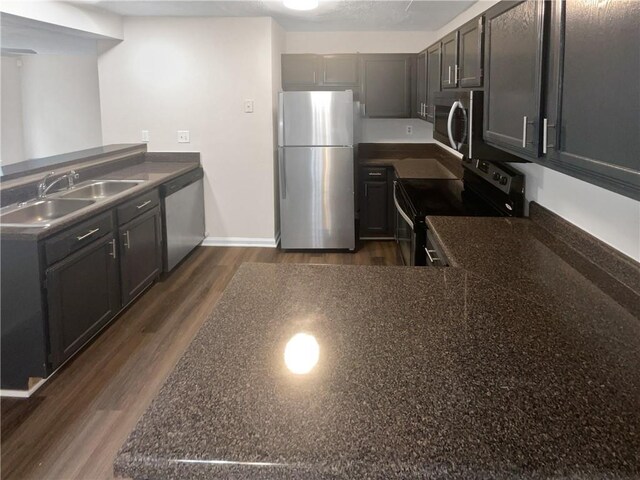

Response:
(278, 90), (353, 147)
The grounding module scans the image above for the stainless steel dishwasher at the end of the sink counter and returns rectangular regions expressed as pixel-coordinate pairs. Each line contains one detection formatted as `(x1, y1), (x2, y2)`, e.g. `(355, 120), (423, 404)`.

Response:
(160, 168), (204, 272)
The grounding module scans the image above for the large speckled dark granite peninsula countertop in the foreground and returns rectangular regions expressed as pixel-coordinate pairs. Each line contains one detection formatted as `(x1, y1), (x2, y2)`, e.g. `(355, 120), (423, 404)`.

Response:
(114, 264), (640, 479)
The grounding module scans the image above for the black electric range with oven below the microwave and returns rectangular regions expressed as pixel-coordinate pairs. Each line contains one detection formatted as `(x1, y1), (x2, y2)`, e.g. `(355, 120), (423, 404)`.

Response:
(393, 160), (524, 266)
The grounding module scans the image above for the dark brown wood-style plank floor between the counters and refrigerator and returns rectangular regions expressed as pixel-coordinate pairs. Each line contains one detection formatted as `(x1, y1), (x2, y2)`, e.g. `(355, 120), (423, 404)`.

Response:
(0, 242), (400, 480)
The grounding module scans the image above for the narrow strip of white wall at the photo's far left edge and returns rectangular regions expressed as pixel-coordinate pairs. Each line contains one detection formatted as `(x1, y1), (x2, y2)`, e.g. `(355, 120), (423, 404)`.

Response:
(0, 57), (24, 165)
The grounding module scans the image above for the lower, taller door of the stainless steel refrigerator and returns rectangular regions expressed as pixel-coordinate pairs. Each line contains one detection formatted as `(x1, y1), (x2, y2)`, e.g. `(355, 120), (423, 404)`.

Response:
(279, 147), (356, 250)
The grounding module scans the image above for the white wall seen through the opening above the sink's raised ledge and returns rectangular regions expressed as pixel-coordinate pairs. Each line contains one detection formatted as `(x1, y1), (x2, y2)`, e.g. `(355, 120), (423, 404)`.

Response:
(21, 54), (102, 159)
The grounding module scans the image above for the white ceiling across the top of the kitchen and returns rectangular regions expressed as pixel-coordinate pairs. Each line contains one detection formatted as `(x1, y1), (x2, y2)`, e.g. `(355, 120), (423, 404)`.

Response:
(80, 0), (476, 31)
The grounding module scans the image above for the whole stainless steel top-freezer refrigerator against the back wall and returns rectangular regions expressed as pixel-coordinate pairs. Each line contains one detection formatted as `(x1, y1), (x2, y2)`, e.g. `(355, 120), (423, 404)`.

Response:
(278, 91), (355, 250)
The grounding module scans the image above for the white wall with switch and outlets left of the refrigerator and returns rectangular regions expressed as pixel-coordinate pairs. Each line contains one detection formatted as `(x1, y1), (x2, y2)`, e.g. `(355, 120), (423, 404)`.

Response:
(98, 17), (279, 244)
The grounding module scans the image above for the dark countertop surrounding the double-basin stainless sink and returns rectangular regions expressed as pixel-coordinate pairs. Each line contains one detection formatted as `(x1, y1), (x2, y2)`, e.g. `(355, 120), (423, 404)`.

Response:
(0, 161), (200, 240)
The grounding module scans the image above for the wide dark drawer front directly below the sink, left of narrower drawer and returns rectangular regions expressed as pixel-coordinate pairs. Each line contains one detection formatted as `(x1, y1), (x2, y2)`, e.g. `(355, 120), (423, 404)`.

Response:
(44, 211), (113, 266)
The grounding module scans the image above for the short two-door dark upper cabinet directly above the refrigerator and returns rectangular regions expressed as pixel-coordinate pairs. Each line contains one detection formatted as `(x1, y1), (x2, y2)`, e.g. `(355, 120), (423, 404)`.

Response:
(282, 54), (359, 90)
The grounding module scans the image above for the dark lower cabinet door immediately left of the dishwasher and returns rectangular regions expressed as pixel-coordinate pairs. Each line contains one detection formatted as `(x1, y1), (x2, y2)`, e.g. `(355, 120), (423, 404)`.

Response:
(119, 207), (162, 305)
